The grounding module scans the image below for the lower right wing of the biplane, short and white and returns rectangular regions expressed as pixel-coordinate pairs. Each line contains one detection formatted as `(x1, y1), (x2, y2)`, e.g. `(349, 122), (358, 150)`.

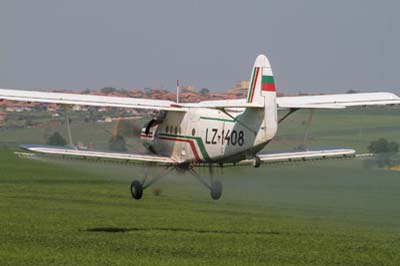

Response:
(236, 148), (356, 164)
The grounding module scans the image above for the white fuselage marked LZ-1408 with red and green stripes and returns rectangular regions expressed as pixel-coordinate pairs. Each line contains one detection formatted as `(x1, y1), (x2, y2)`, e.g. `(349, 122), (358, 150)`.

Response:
(141, 108), (277, 163)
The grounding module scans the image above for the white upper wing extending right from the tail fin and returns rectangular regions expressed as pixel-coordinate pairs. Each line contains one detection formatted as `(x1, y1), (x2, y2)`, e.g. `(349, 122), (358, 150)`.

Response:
(276, 92), (400, 109)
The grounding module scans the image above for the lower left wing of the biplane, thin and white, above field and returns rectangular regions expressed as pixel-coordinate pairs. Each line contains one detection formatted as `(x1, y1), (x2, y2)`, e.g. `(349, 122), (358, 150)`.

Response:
(20, 145), (178, 165)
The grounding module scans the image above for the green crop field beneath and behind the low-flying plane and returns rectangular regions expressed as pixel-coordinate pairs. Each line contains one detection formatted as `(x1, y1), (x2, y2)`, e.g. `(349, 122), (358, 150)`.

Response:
(0, 109), (400, 266)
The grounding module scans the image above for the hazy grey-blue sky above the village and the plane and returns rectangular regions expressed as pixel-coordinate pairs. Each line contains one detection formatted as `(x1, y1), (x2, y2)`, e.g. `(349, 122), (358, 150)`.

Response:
(0, 0), (400, 93)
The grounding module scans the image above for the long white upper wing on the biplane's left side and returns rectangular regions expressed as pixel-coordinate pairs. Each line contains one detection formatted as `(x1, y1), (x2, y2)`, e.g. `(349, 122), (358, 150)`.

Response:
(0, 89), (186, 112)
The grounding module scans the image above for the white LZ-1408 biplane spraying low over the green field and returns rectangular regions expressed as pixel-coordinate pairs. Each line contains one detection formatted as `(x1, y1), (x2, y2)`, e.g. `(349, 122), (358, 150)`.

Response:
(0, 54), (400, 200)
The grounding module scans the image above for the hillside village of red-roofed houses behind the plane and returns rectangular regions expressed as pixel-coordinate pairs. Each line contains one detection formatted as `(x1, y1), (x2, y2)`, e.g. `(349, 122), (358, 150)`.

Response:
(0, 81), (290, 128)
